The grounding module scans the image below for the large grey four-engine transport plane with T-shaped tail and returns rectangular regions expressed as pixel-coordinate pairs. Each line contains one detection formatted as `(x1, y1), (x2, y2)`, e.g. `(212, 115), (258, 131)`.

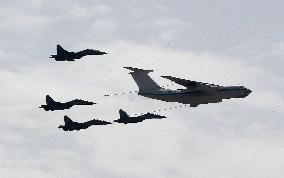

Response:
(124, 67), (251, 107)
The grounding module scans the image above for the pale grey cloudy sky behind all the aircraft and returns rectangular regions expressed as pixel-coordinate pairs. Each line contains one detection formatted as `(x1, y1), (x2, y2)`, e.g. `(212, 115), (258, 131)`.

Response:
(0, 0), (284, 178)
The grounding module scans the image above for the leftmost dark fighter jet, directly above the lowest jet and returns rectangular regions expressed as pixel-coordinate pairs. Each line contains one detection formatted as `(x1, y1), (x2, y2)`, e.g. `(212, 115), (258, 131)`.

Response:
(39, 95), (96, 111)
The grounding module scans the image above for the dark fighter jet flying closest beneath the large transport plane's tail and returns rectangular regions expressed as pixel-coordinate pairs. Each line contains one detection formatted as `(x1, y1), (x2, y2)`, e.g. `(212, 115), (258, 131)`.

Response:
(113, 109), (166, 124)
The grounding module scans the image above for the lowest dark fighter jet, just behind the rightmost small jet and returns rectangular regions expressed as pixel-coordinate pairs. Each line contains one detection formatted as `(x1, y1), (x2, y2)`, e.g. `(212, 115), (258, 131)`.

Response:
(58, 116), (111, 131)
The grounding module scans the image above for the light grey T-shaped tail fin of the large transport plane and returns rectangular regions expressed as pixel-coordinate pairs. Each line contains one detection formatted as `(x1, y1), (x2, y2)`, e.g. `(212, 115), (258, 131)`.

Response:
(124, 67), (161, 93)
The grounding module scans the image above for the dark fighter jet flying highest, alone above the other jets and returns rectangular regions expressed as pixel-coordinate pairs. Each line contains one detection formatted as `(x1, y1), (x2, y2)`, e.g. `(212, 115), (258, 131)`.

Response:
(50, 45), (107, 61)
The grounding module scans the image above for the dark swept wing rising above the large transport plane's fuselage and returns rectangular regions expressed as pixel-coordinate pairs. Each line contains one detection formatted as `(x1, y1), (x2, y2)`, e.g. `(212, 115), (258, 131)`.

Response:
(161, 76), (220, 90)
